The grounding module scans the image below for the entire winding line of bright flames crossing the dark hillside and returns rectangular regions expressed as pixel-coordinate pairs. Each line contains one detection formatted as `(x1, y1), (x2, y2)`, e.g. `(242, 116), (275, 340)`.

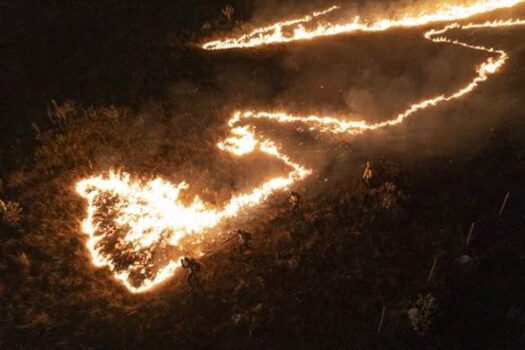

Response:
(76, 0), (525, 293)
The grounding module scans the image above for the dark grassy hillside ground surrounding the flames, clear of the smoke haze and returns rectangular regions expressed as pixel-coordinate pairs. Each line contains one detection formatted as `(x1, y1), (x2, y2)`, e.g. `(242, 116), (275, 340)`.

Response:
(0, 1), (525, 349)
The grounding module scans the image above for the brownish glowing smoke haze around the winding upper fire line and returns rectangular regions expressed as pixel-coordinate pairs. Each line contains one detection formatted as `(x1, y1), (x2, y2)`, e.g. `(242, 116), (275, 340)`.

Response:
(118, 1), (524, 205)
